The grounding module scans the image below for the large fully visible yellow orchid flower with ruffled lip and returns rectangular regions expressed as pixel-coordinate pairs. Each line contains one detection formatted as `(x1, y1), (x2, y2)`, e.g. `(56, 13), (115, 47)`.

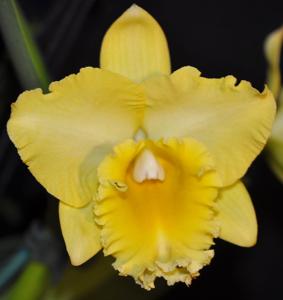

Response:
(8, 5), (275, 289)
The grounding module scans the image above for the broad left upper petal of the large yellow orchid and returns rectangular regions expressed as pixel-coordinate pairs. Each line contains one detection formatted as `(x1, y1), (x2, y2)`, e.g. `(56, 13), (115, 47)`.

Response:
(8, 68), (144, 207)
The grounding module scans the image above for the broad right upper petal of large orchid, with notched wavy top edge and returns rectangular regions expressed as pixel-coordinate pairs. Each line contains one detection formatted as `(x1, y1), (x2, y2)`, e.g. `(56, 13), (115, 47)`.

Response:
(143, 67), (275, 185)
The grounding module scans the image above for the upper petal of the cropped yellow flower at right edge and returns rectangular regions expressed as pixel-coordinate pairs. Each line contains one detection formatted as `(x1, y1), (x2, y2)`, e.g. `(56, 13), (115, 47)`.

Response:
(264, 26), (283, 98)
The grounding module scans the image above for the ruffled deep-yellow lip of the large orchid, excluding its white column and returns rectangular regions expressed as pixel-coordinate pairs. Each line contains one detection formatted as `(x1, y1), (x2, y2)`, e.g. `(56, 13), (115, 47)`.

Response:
(95, 138), (221, 289)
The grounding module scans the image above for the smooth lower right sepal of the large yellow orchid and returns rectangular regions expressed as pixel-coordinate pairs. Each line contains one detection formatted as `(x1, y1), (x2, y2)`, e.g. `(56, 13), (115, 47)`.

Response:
(216, 181), (257, 247)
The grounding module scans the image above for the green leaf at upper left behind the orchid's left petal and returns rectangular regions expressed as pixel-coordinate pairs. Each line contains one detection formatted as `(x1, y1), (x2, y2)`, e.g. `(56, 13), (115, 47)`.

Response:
(0, 0), (49, 91)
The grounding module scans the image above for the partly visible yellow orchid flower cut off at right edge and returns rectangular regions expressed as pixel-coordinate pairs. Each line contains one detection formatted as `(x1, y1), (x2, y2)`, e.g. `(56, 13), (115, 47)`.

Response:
(264, 26), (283, 182)
